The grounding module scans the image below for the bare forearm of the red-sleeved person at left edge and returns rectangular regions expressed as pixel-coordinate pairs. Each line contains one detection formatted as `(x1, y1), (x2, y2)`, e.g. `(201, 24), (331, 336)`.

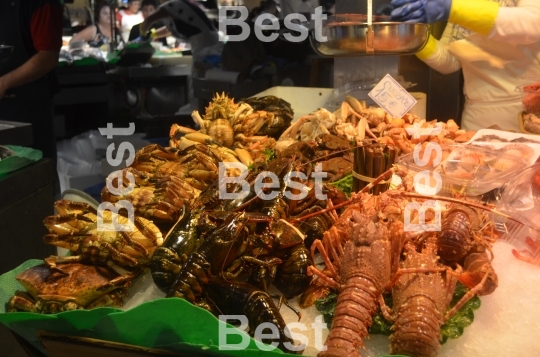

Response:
(0, 51), (58, 99)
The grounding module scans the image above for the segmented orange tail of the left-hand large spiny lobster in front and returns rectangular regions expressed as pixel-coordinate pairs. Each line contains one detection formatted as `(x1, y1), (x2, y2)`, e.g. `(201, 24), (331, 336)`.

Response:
(318, 277), (378, 357)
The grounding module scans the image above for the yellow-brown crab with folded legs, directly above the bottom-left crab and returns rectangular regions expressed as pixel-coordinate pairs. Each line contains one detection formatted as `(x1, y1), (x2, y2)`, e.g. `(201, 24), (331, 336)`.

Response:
(43, 200), (163, 278)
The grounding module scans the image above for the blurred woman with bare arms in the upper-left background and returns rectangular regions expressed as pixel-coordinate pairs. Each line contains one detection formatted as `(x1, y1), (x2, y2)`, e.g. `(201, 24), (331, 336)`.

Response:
(69, 1), (123, 47)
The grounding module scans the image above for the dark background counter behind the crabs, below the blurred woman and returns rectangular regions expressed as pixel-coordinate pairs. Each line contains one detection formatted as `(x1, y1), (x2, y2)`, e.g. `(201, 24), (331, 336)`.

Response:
(54, 64), (194, 137)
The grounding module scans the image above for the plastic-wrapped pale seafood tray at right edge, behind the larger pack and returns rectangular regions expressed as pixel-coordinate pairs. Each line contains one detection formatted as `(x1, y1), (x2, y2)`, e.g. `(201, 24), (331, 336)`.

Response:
(466, 129), (540, 165)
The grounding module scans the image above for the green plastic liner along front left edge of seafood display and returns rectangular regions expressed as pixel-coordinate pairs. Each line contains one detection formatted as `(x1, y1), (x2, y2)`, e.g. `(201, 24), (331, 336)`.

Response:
(0, 259), (412, 357)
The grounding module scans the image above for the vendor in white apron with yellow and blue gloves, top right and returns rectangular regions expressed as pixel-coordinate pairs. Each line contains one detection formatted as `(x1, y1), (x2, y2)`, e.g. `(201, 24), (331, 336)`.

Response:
(392, 0), (540, 132)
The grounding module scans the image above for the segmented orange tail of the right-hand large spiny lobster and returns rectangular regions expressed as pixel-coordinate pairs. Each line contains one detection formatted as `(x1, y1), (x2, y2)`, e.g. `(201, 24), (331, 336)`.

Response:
(390, 295), (441, 357)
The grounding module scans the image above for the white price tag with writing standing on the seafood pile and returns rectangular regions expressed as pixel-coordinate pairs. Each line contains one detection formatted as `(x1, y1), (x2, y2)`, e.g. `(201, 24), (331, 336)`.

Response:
(368, 74), (416, 118)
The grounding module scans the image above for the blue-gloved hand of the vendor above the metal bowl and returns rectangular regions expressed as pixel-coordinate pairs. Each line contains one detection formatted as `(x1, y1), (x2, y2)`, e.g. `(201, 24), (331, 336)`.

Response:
(390, 0), (452, 24)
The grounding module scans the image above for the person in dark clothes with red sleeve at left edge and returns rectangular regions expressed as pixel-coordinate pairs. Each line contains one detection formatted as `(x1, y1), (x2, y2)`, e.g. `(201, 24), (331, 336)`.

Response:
(0, 0), (63, 193)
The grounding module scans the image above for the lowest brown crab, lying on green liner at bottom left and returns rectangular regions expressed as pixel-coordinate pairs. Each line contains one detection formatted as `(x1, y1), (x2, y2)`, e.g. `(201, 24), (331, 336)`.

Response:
(6, 263), (131, 314)
